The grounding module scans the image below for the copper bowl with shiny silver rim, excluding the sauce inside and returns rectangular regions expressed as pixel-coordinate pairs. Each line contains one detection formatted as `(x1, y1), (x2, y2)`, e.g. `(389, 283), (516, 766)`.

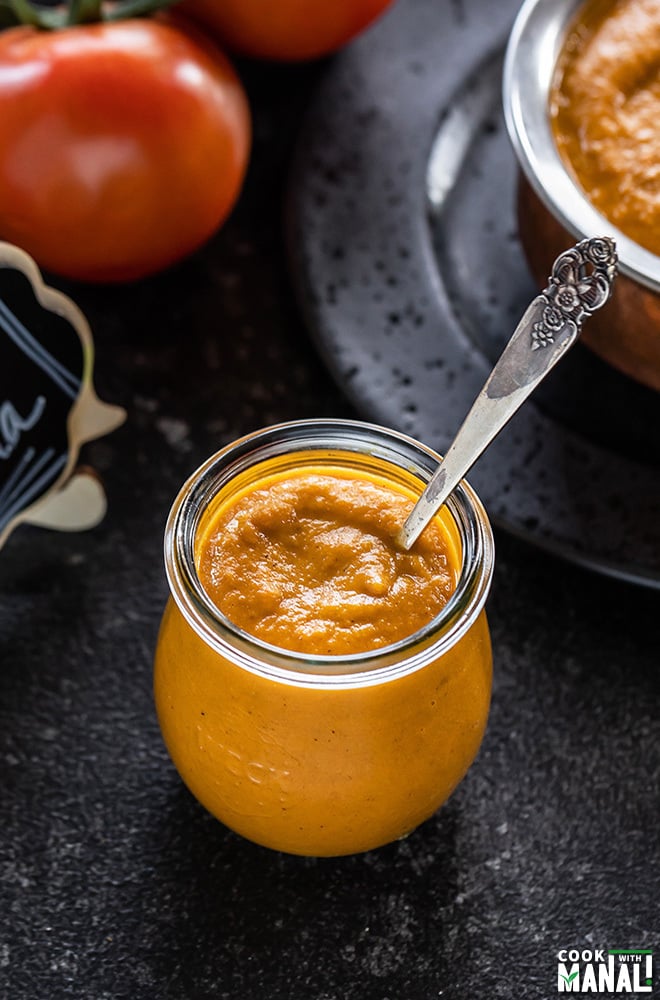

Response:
(503, 0), (660, 391)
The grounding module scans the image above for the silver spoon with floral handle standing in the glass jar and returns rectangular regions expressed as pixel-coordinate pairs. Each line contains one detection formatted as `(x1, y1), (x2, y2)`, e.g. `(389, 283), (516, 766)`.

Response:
(397, 236), (617, 549)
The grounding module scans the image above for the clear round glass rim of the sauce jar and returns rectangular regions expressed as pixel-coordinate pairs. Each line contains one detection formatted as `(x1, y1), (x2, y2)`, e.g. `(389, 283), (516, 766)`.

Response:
(164, 418), (494, 687)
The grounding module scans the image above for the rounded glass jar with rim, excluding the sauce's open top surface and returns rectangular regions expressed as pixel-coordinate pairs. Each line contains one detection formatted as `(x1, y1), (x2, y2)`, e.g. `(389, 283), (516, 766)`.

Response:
(154, 420), (493, 855)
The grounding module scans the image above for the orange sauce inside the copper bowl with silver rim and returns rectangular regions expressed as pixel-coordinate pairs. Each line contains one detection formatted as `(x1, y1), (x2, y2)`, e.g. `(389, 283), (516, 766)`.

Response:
(550, 0), (660, 255)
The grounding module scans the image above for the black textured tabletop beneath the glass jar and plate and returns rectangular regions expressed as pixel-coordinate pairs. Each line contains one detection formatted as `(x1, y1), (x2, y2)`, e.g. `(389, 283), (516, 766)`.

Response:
(0, 9), (660, 1000)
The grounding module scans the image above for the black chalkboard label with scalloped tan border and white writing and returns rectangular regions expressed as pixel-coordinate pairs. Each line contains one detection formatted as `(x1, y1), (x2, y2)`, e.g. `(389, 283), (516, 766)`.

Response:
(0, 242), (126, 546)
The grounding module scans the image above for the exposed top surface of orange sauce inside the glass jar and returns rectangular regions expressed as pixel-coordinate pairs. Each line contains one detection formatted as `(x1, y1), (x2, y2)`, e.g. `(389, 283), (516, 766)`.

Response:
(198, 471), (457, 656)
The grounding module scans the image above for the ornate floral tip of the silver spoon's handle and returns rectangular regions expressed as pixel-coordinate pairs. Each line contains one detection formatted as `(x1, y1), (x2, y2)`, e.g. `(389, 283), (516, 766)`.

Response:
(531, 236), (617, 351)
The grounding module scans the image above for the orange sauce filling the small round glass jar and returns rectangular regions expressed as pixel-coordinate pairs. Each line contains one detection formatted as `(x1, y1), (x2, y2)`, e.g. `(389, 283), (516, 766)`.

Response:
(155, 421), (492, 855)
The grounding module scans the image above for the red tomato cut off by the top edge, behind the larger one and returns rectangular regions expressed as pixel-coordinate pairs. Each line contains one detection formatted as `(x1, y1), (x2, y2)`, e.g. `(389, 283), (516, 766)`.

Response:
(180, 0), (392, 61)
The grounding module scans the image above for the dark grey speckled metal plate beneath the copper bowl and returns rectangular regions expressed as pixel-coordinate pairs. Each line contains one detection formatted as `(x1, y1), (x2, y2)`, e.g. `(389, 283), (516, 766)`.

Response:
(287, 0), (660, 584)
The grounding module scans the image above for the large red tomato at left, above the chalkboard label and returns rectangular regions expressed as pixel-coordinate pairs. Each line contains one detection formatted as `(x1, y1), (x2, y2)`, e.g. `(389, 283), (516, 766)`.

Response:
(0, 19), (250, 281)
